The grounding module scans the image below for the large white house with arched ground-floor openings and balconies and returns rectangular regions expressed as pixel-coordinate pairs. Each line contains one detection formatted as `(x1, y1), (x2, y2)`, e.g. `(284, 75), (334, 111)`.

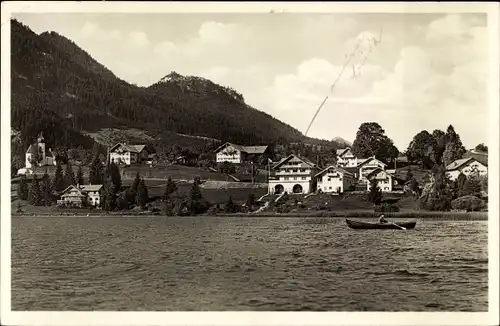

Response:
(268, 154), (318, 194)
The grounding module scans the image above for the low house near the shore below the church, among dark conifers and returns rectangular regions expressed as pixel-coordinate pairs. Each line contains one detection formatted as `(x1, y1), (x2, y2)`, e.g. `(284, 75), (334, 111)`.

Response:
(57, 184), (102, 207)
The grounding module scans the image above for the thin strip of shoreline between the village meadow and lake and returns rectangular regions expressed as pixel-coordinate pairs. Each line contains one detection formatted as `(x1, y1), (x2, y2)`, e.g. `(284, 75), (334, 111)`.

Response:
(11, 211), (488, 221)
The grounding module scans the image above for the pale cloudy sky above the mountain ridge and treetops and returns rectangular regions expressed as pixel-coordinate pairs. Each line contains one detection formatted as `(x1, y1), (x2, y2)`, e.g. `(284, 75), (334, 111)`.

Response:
(14, 13), (488, 151)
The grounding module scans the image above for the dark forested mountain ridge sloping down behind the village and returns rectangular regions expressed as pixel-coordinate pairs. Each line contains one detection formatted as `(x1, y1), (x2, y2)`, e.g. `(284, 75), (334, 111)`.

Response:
(11, 20), (324, 153)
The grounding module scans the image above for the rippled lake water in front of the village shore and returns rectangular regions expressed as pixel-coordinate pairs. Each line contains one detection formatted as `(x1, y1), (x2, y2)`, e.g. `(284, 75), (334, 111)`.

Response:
(12, 217), (488, 311)
